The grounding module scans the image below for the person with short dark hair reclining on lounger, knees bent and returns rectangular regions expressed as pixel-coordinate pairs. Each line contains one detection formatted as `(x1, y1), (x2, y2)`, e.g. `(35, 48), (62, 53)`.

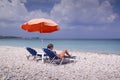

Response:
(47, 43), (71, 58)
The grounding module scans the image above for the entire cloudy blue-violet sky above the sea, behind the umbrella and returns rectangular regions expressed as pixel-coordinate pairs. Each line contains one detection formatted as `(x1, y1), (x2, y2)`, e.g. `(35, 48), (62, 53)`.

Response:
(0, 0), (120, 39)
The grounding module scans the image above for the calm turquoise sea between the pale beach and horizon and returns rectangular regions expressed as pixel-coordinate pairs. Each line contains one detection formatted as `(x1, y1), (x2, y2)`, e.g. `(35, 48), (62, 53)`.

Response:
(0, 39), (120, 54)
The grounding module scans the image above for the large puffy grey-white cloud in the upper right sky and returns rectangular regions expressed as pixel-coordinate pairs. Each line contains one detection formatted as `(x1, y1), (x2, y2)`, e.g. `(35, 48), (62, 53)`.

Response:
(51, 0), (117, 24)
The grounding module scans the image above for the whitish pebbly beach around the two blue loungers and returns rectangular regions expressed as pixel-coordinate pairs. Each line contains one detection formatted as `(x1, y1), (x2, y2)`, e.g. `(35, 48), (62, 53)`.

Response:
(0, 46), (120, 80)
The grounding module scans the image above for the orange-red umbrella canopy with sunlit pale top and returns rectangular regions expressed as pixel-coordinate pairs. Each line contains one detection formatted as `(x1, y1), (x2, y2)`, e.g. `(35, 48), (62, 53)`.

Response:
(21, 18), (60, 33)
